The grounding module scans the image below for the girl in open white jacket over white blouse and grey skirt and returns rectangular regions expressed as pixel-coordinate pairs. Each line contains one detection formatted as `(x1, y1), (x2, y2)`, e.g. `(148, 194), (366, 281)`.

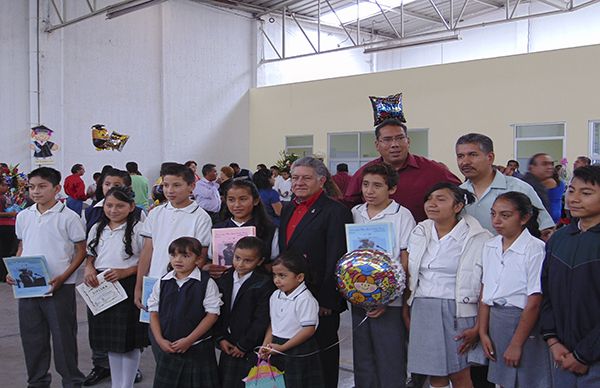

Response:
(405, 183), (492, 388)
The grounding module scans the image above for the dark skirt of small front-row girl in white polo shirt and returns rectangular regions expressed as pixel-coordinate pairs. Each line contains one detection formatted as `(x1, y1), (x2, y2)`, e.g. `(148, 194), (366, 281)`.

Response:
(271, 336), (326, 388)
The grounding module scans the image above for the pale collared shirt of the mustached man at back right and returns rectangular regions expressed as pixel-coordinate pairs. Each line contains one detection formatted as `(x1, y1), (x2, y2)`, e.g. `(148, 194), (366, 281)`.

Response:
(460, 172), (555, 235)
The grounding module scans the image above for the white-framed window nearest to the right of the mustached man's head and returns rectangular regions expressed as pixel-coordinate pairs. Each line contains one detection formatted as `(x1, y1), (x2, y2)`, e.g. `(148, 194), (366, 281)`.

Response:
(512, 123), (566, 167)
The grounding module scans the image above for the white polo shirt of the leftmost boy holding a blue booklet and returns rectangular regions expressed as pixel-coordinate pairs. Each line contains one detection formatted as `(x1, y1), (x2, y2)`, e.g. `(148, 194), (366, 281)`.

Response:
(15, 202), (85, 284)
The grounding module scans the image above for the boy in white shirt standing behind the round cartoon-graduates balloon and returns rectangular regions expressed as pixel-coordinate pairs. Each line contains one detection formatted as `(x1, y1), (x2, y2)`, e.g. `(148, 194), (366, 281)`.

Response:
(352, 163), (415, 388)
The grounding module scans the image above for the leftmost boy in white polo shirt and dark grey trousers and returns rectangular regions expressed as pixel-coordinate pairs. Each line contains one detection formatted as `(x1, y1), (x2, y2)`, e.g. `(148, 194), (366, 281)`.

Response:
(7, 167), (86, 387)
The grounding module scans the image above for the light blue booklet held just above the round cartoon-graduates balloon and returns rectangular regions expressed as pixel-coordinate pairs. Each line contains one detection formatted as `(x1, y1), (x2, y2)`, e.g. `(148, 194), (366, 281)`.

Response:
(346, 222), (394, 256)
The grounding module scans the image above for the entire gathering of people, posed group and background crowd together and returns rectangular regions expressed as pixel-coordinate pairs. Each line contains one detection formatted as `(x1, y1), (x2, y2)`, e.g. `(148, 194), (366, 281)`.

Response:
(0, 119), (600, 388)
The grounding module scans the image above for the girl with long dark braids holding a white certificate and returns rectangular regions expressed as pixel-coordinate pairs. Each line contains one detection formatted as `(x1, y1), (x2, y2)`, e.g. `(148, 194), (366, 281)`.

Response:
(84, 187), (148, 388)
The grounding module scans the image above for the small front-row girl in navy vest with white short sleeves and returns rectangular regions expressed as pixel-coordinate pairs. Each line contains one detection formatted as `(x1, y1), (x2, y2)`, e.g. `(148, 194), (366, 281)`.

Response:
(148, 237), (222, 388)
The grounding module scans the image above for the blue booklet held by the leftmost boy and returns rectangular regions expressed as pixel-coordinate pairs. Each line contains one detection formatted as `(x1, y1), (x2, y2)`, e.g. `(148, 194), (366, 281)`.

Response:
(4, 256), (52, 299)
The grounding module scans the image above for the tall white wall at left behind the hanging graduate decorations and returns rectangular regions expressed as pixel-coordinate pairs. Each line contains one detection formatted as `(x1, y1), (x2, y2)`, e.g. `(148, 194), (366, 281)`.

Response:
(0, 0), (256, 185)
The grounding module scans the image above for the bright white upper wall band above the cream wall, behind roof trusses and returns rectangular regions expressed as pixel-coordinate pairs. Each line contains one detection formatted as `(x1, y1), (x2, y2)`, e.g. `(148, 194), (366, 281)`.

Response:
(257, 3), (600, 86)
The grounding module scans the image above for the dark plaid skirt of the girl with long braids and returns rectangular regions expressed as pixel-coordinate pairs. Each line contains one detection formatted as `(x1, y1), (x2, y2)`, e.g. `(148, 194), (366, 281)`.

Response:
(88, 275), (149, 353)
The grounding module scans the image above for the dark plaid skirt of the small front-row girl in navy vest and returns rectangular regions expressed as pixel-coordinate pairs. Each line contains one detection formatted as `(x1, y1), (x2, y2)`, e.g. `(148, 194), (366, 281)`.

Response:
(153, 339), (221, 388)
